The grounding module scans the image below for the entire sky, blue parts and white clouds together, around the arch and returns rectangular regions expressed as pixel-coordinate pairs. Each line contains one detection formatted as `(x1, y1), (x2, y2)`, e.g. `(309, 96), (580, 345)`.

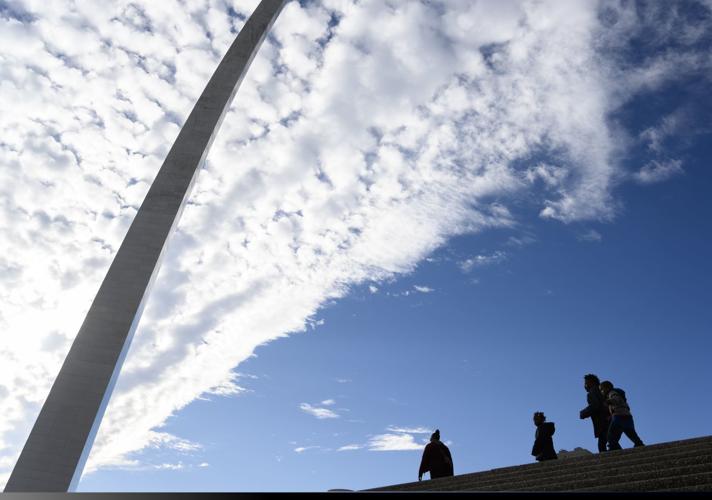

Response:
(0, 0), (712, 491)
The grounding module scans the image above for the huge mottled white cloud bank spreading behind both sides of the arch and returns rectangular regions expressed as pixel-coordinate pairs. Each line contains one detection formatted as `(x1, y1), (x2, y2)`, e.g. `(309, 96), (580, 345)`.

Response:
(0, 0), (709, 483)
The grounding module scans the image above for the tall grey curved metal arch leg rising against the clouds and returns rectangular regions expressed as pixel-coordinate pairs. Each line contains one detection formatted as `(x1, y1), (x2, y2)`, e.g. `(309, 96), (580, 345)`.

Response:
(5, 0), (287, 492)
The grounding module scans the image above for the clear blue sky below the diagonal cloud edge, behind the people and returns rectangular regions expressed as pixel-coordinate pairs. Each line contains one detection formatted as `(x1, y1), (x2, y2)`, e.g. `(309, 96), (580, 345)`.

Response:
(80, 128), (712, 491)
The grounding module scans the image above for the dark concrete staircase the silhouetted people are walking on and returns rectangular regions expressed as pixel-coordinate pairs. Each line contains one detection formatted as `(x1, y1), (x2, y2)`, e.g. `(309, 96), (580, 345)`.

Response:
(368, 436), (712, 492)
